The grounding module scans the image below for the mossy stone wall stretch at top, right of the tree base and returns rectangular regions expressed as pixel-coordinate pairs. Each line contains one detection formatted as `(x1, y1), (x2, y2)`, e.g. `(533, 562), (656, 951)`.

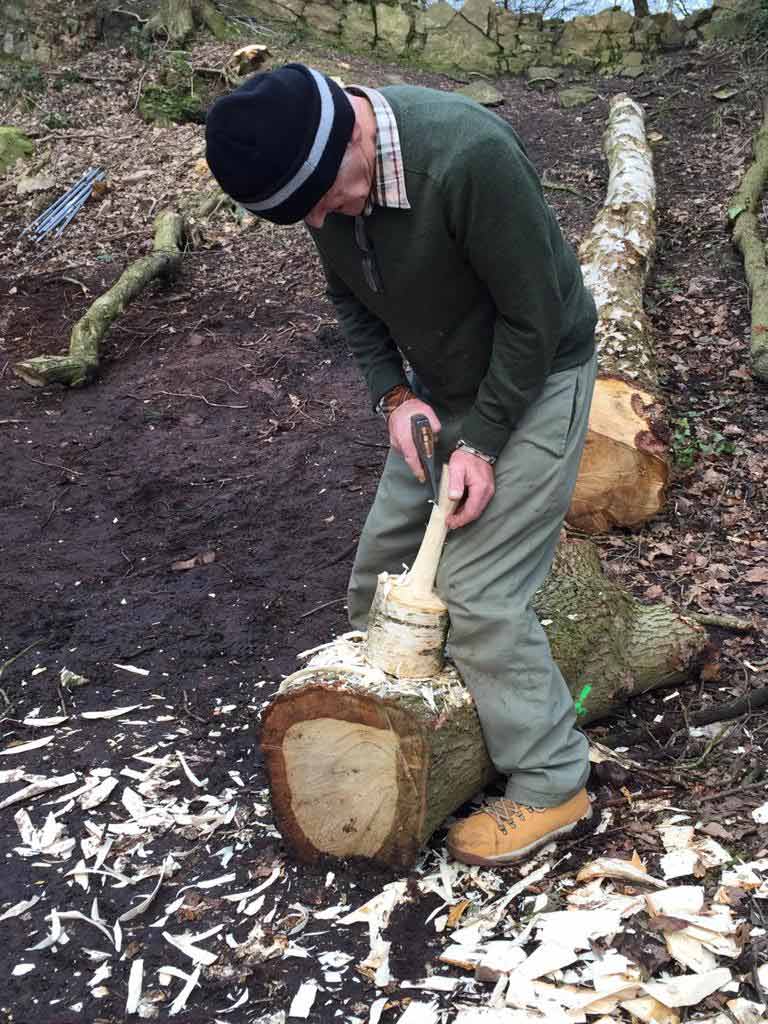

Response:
(241, 0), (742, 75)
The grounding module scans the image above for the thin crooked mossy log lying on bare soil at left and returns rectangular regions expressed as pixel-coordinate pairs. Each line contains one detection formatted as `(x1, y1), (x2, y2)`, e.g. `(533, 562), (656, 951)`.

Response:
(13, 210), (186, 387)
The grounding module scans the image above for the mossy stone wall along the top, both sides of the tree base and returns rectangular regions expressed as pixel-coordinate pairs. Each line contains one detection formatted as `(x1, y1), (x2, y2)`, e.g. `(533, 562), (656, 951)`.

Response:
(0, 0), (749, 76)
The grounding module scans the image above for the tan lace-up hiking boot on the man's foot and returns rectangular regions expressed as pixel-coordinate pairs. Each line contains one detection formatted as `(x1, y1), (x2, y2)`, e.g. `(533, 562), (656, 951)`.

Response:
(447, 790), (592, 866)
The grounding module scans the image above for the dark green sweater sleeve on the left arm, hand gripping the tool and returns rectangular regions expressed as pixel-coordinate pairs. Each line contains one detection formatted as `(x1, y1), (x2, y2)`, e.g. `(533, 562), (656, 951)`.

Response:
(315, 242), (408, 409)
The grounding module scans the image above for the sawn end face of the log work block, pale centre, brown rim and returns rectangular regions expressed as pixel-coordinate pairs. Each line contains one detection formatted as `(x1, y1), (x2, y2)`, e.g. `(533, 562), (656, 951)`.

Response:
(262, 679), (429, 864)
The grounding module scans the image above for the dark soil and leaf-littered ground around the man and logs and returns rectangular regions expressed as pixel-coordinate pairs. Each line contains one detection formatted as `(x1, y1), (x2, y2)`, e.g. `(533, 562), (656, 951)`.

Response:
(0, 22), (768, 1024)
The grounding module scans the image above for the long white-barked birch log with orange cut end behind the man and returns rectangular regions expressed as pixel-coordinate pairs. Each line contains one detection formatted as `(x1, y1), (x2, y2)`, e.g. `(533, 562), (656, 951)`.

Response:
(566, 94), (670, 534)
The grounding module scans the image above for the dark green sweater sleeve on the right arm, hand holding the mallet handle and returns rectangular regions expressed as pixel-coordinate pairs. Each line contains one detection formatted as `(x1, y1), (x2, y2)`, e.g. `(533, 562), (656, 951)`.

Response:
(444, 126), (562, 455)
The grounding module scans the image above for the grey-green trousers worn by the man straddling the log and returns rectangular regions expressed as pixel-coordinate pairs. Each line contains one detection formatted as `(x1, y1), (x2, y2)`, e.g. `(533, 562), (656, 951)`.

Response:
(348, 358), (597, 807)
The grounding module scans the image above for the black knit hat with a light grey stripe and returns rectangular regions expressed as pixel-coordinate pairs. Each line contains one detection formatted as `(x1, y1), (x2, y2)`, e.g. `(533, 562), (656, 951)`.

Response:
(206, 63), (354, 224)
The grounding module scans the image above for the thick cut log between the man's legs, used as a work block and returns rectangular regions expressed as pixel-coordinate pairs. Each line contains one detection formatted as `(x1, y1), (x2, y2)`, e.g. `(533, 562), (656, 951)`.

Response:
(262, 541), (707, 865)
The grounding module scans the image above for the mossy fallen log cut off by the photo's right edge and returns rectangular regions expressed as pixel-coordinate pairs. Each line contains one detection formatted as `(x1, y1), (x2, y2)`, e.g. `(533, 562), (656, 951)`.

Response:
(728, 98), (768, 383)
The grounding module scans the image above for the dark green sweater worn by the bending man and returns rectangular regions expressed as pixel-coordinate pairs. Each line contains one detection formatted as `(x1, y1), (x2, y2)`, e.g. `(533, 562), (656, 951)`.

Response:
(310, 86), (596, 455)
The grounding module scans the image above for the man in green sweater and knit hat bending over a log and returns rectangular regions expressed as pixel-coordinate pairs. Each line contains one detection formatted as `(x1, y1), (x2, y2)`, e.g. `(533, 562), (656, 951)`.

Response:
(207, 65), (596, 864)
